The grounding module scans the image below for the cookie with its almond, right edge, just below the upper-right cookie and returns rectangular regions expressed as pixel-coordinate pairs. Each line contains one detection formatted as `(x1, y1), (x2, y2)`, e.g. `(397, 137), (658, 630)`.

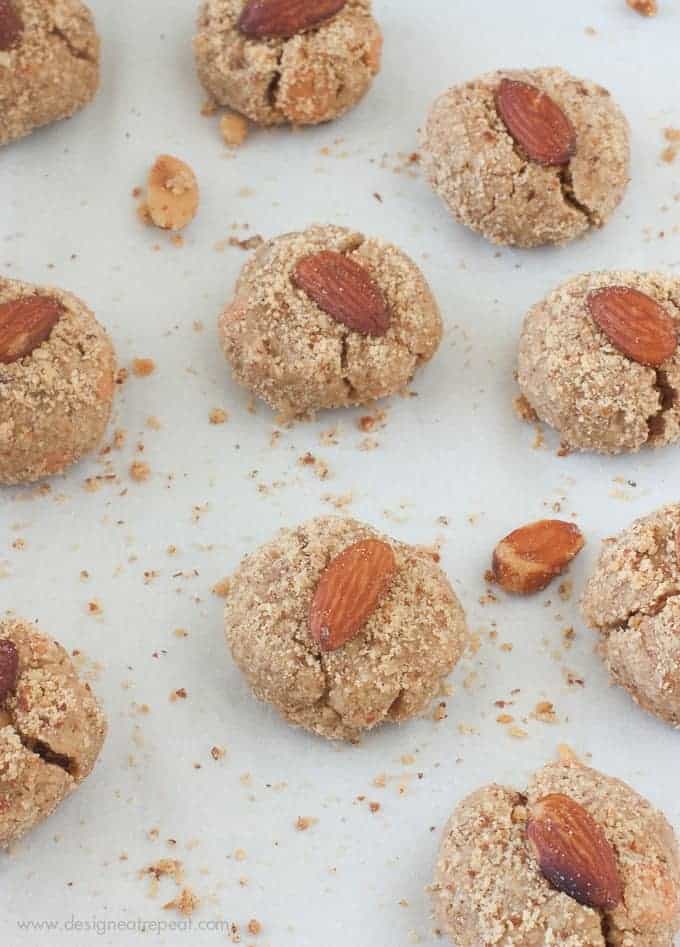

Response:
(517, 270), (680, 454)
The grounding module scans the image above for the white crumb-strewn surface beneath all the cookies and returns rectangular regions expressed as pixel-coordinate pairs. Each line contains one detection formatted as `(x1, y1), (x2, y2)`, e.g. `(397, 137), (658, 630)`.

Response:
(0, 0), (680, 947)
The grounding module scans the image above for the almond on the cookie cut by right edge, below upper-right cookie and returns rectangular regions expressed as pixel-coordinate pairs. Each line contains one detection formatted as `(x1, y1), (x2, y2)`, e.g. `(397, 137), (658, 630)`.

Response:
(586, 286), (678, 368)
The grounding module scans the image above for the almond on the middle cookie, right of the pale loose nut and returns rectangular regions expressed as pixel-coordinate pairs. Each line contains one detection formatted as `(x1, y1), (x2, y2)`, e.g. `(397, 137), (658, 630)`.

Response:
(292, 250), (390, 336)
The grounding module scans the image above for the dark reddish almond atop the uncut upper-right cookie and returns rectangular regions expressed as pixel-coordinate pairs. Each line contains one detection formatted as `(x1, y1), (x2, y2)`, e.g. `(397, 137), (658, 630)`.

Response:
(496, 79), (576, 165)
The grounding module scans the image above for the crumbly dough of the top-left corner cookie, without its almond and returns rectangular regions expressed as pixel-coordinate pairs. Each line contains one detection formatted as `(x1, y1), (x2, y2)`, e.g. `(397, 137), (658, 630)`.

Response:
(0, 0), (99, 145)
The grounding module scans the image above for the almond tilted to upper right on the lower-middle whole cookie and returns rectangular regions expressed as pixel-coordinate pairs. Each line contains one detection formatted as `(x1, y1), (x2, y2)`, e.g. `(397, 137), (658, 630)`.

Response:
(309, 539), (396, 651)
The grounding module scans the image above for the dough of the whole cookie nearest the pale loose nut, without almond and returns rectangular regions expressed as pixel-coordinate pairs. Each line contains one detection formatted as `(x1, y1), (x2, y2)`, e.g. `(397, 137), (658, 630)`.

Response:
(219, 226), (442, 421)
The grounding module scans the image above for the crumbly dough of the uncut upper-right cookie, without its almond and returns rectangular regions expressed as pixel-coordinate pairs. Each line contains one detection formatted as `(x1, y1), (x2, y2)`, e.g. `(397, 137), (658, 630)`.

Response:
(422, 68), (629, 247)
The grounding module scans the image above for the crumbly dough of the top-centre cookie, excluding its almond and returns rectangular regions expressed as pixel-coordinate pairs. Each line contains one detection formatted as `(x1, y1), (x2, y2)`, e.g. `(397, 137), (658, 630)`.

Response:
(194, 0), (382, 125)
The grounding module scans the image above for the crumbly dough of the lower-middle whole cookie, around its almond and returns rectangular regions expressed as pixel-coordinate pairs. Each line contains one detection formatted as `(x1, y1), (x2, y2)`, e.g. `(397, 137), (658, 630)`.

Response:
(225, 516), (467, 741)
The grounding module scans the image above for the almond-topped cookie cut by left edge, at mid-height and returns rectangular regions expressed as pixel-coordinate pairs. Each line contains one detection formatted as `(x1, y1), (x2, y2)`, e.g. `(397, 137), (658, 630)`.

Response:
(0, 279), (115, 484)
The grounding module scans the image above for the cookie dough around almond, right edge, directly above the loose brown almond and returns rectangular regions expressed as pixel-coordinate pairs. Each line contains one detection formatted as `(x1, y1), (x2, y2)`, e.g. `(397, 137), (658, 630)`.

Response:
(517, 270), (680, 454)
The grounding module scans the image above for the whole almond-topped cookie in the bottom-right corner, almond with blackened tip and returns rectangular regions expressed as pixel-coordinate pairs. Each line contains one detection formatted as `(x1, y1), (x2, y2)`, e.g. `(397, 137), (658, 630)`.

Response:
(432, 761), (680, 947)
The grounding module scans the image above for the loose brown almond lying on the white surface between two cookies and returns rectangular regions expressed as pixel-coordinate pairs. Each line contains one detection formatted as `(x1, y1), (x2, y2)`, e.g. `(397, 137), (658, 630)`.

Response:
(492, 520), (585, 595)
